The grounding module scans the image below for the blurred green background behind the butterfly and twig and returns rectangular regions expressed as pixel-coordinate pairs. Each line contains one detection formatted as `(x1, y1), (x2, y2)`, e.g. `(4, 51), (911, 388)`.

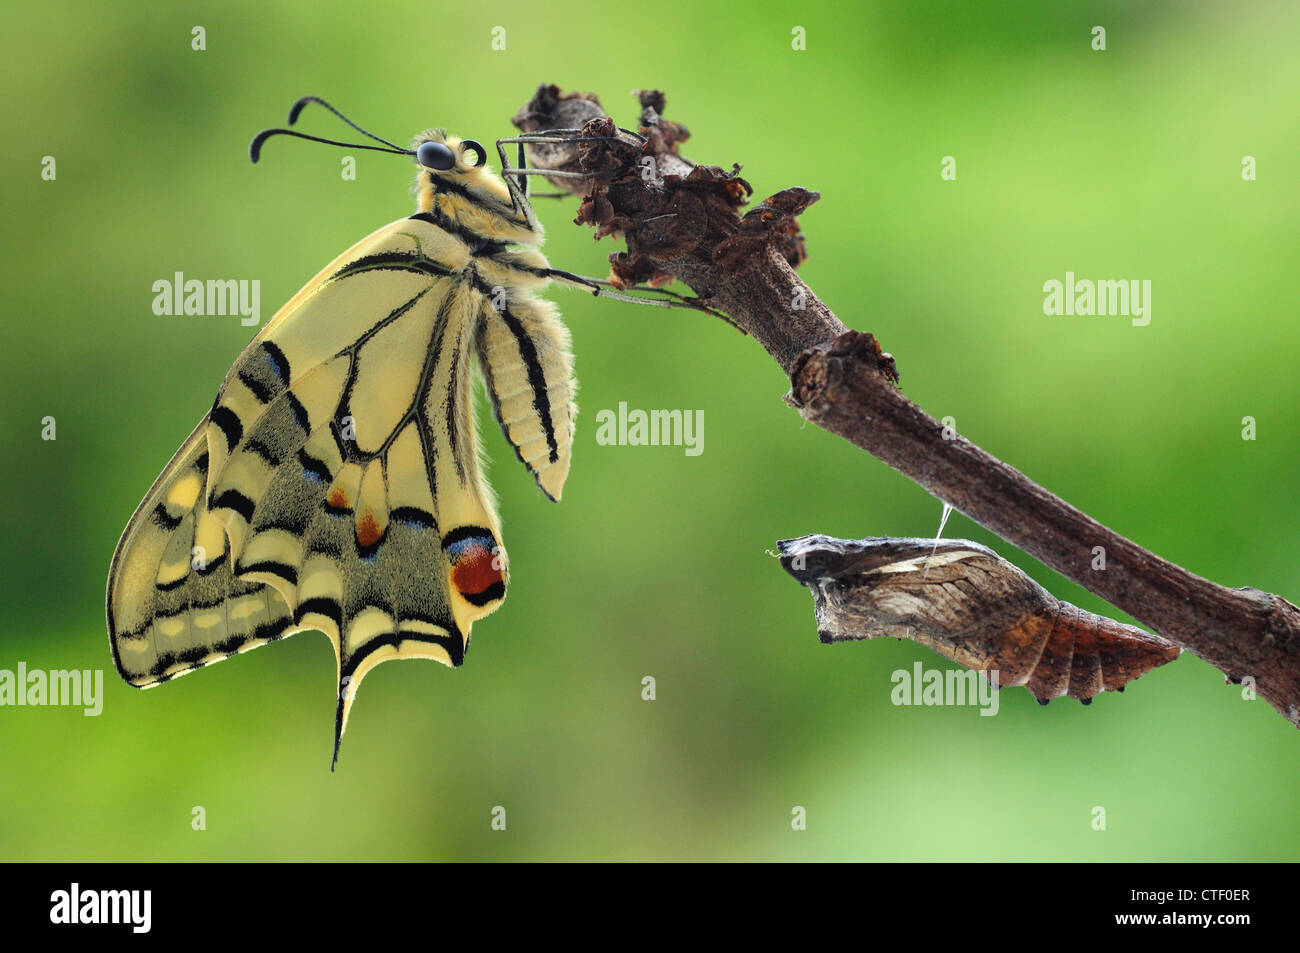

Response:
(0, 0), (1300, 861)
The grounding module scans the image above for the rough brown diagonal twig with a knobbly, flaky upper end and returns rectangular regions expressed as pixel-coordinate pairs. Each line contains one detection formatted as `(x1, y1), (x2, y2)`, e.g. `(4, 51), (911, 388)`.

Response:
(515, 86), (1300, 724)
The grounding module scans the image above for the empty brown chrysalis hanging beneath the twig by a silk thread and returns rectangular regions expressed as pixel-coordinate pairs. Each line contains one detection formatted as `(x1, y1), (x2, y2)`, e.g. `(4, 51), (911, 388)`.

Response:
(777, 536), (1179, 705)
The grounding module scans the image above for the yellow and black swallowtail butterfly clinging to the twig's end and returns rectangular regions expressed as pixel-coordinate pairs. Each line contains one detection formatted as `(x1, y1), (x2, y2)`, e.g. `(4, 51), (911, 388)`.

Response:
(107, 96), (689, 767)
